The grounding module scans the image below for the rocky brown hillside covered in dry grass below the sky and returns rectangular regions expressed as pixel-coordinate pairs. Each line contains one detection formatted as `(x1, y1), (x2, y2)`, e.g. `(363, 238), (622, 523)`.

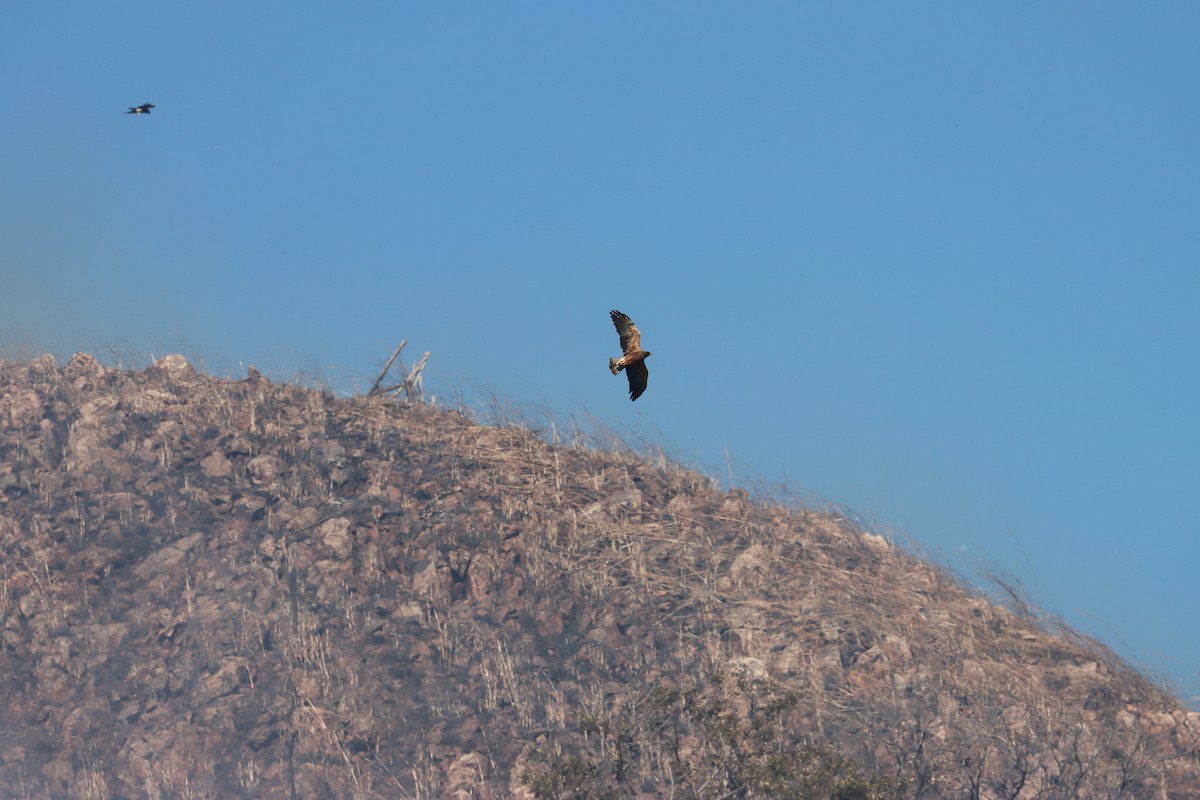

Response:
(0, 355), (1200, 799)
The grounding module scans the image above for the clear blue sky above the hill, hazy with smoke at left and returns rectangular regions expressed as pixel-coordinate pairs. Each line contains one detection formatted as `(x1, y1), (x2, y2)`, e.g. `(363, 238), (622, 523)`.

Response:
(0, 0), (1200, 703)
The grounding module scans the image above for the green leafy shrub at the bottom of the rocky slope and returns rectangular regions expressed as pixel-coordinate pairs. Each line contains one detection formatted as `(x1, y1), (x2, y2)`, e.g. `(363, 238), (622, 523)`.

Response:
(521, 674), (902, 800)
